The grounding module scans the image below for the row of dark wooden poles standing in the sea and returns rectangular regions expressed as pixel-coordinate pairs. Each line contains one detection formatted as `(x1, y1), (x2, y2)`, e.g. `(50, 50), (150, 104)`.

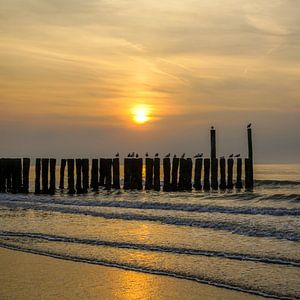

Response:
(0, 128), (253, 194)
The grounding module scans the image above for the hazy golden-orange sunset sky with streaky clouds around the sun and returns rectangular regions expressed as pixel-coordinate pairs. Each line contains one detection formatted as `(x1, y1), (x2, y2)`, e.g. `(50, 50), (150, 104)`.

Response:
(0, 0), (300, 163)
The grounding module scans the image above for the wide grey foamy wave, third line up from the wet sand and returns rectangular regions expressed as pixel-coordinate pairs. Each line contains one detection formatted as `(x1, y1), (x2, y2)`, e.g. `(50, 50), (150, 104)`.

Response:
(0, 201), (300, 241)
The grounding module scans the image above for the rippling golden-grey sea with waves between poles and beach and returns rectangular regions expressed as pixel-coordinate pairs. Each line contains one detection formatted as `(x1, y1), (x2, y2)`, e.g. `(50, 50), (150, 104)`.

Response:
(0, 165), (300, 299)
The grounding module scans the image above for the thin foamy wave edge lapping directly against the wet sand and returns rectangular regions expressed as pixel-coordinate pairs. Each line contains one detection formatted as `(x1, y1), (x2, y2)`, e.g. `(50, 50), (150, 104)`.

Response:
(0, 242), (296, 300)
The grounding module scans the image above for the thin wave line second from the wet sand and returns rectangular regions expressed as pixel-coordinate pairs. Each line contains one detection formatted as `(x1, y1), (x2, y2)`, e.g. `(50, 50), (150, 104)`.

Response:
(0, 231), (300, 267)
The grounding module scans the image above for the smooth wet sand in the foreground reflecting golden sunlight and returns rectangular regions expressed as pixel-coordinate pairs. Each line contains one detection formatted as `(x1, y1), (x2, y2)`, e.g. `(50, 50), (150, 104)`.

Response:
(0, 248), (264, 300)
